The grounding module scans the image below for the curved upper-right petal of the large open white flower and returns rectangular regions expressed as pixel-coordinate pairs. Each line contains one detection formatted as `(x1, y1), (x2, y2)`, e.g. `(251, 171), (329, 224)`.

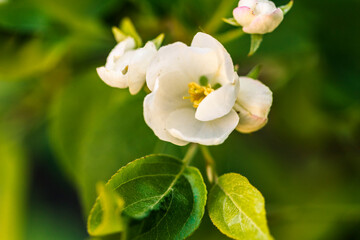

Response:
(191, 32), (234, 85)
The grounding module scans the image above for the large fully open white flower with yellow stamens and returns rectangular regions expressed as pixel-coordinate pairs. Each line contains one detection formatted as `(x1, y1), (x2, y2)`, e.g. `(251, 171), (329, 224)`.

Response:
(144, 33), (239, 145)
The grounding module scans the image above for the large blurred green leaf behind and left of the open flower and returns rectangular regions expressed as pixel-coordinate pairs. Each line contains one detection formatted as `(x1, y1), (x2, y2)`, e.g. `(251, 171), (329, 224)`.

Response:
(50, 70), (158, 213)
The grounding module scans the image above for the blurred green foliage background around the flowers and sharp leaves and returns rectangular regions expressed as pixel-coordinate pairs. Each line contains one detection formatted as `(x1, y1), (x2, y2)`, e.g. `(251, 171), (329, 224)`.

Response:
(0, 0), (360, 240)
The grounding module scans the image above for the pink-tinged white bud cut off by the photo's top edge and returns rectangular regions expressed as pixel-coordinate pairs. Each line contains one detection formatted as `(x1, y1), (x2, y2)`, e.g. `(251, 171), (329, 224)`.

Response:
(233, 0), (284, 34)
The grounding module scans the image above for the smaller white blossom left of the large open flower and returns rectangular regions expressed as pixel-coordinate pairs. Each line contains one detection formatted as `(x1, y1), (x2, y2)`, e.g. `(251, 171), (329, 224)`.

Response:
(96, 37), (157, 95)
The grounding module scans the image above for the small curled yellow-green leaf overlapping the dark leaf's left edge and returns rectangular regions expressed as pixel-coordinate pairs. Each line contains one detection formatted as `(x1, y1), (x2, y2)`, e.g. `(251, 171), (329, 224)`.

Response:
(87, 183), (125, 236)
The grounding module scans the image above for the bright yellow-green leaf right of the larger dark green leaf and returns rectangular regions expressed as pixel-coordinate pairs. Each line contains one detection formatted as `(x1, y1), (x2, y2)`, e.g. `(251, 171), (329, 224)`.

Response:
(208, 173), (272, 240)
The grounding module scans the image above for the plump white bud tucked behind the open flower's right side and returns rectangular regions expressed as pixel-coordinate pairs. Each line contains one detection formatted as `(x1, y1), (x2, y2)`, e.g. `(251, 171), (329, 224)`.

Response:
(234, 77), (272, 133)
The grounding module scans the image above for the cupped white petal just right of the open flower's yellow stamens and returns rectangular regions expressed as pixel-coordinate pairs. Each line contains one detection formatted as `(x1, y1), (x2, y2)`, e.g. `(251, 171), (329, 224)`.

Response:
(195, 79), (239, 121)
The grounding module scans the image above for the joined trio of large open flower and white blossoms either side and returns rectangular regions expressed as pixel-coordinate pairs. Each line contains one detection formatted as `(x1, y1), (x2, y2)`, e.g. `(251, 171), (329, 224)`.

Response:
(97, 33), (272, 145)
